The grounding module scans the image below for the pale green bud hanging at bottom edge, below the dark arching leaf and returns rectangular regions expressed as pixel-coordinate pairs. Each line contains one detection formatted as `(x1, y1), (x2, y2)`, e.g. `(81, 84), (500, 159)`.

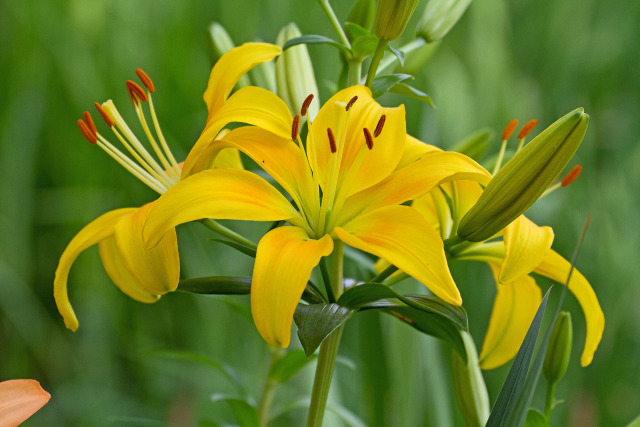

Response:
(451, 331), (489, 426)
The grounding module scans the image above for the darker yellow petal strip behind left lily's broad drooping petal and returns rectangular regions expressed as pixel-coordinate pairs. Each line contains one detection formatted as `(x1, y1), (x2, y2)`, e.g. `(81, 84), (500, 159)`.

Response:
(98, 236), (160, 304)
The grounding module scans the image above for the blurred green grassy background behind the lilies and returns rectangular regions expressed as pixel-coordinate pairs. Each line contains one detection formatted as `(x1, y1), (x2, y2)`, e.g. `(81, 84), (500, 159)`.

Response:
(0, 0), (640, 426)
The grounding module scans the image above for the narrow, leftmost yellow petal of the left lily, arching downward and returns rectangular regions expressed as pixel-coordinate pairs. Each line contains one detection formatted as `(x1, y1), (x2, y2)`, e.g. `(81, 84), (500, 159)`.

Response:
(53, 208), (137, 331)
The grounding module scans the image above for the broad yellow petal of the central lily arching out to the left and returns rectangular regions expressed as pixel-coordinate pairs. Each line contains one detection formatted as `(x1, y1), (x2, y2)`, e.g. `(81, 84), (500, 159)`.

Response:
(143, 169), (299, 247)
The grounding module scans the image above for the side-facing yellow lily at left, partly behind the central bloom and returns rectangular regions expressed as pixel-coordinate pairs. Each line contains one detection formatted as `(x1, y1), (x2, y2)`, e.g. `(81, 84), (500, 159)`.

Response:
(54, 43), (289, 331)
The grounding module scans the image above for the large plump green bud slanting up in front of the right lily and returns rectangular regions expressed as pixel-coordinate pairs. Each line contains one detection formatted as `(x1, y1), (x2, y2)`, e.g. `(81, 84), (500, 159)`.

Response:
(458, 108), (589, 242)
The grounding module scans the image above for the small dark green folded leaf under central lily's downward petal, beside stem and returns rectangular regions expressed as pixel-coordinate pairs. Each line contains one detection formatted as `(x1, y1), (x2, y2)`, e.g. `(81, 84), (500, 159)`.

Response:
(293, 303), (357, 357)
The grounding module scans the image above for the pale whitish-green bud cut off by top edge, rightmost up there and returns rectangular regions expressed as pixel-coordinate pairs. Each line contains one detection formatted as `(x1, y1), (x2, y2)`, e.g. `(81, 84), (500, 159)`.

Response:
(416, 0), (471, 43)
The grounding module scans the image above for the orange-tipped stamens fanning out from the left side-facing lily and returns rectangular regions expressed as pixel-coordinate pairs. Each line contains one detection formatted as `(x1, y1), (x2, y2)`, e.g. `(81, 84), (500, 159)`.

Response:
(78, 69), (181, 194)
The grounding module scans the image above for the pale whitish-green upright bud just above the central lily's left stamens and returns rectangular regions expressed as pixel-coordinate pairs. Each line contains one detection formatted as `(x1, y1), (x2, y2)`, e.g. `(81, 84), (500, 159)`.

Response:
(276, 23), (320, 120)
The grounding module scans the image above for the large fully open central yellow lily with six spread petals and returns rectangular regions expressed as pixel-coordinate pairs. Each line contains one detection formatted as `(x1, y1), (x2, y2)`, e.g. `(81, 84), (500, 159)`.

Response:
(144, 86), (490, 347)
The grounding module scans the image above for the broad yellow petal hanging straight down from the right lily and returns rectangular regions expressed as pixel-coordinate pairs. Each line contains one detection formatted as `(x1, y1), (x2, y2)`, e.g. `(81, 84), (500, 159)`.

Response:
(480, 264), (542, 369)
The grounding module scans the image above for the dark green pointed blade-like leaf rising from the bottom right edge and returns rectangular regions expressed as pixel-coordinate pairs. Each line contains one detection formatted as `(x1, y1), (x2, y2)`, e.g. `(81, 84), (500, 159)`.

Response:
(487, 288), (551, 427)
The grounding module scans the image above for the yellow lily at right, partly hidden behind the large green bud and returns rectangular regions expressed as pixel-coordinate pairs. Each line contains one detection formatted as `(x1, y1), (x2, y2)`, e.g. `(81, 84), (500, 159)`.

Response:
(412, 143), (604, 369)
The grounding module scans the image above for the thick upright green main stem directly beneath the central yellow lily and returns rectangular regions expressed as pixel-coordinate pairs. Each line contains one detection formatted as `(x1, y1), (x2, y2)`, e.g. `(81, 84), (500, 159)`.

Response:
(307, 241), (344, 427)
